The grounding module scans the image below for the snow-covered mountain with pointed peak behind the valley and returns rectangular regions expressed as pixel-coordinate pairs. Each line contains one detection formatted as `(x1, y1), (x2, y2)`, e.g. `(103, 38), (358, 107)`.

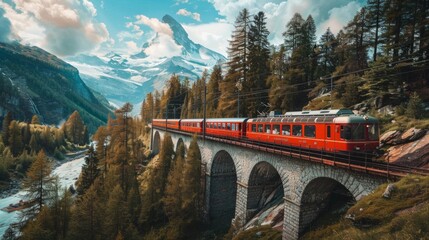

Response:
(66, 15), (226, 109)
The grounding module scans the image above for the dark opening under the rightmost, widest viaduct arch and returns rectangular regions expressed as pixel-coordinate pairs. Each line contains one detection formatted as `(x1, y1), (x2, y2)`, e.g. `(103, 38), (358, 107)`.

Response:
(299, 176), (356, 233)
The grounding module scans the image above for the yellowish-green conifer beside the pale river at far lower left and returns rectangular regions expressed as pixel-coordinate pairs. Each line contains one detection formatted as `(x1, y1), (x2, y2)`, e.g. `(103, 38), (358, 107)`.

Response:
(23, 150), (55, 218)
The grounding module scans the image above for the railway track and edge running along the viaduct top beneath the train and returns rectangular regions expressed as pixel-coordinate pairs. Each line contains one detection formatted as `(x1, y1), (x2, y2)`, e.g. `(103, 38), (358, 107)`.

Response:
(154, 126), (429, 178)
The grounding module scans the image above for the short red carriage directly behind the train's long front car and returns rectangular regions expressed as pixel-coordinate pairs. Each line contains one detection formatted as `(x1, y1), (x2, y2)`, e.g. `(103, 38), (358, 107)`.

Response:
(206, 118), (247, 138)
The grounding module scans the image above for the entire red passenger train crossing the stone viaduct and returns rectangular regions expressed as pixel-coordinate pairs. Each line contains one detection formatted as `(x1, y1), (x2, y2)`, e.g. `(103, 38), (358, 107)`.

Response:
(153, 109), (379, 152)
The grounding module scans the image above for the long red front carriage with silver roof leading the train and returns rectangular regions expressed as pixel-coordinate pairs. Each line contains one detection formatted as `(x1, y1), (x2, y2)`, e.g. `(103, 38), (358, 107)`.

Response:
(246, 109), (378, 152)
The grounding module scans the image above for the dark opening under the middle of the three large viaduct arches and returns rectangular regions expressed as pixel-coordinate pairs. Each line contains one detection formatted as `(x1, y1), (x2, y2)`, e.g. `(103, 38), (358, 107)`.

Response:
(246, 161), (284, 221)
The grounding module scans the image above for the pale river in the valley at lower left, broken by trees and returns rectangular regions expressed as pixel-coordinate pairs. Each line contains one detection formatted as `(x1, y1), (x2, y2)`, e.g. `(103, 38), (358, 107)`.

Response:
(0, 157), (85, 236)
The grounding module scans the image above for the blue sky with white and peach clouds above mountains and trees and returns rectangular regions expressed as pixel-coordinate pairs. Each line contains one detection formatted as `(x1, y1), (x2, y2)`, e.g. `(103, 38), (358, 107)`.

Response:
(0, 0), (365, 56)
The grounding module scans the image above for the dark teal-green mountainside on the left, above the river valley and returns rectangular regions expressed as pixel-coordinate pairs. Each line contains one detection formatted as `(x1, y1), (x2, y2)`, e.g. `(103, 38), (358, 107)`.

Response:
(0, 43), (109, 132)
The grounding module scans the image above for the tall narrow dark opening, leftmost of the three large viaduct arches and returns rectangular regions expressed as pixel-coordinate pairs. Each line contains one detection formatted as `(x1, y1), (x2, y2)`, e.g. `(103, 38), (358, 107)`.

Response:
(208, 150), (237, 231)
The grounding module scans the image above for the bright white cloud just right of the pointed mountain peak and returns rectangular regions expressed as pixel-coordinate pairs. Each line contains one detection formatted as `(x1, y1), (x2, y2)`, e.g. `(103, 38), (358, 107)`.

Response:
(183, 22), (234, 56)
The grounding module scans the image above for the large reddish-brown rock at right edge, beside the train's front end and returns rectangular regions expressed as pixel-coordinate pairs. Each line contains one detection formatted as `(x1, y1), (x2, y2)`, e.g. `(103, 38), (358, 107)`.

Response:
(386, 133), (429, 167)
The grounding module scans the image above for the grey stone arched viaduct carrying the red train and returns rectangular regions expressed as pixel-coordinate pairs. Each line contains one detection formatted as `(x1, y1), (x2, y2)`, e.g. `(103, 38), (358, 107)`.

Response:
(152, 129), (386, 239)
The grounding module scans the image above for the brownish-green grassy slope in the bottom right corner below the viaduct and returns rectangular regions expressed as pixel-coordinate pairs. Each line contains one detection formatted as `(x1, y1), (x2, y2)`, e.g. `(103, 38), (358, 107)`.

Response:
(302, 176), (429, 240)
